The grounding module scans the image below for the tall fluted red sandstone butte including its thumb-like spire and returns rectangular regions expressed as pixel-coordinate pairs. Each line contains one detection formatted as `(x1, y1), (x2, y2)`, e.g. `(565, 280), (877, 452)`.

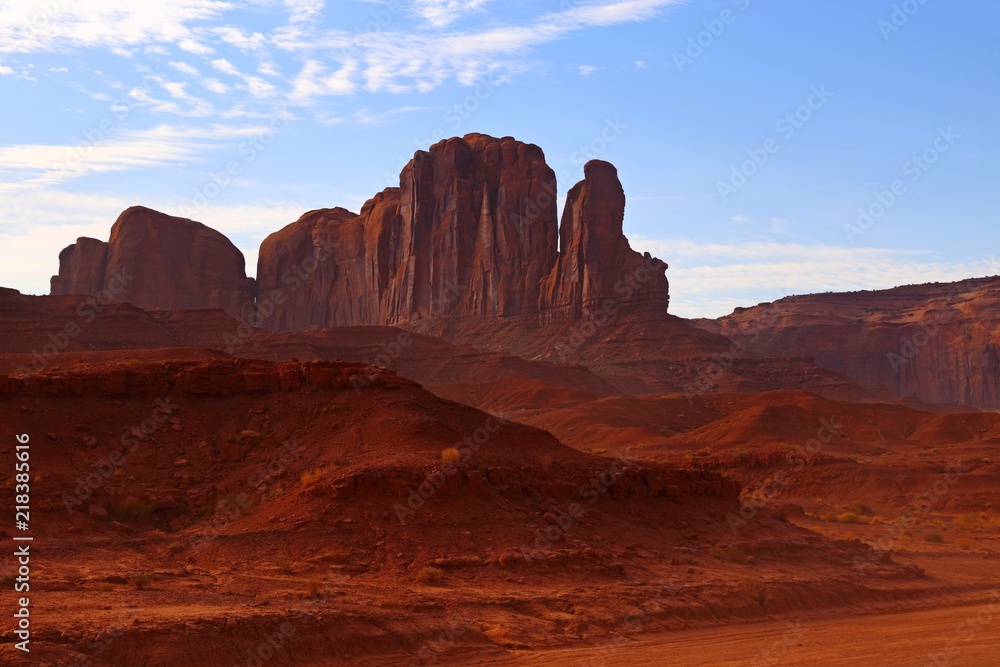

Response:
(257, 134), (667, 331)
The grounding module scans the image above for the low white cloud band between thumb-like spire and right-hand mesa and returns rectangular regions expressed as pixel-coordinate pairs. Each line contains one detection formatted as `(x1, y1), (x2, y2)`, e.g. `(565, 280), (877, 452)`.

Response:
(631, 239), (992, 317)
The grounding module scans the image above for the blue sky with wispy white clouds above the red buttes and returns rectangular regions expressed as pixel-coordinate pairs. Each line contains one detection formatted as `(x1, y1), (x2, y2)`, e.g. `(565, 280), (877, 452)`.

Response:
(0, 0), (1000, 317)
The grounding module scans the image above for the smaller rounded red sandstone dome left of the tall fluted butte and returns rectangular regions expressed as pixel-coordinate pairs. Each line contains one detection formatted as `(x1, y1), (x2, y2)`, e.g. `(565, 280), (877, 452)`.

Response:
(51, 206), (256, 317)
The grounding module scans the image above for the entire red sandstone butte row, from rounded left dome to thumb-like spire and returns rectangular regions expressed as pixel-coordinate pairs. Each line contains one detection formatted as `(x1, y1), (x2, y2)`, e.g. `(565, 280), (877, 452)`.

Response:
(51, 134), (669, 331)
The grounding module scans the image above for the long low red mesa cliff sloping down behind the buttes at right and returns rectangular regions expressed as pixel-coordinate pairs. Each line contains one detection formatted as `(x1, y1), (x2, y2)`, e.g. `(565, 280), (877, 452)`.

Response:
(699, 278), (1000, 410)
